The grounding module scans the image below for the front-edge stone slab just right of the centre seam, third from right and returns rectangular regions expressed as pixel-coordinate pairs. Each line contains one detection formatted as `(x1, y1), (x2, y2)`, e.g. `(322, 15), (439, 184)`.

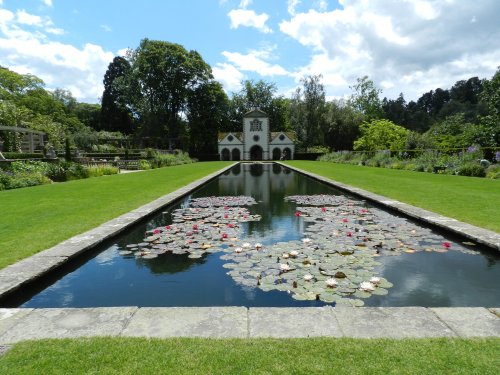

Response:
(248, 307), (342, 338)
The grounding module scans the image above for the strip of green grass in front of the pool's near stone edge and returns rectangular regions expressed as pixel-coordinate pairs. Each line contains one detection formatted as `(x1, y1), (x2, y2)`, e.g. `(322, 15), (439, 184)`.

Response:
(0, 338), (500, 375)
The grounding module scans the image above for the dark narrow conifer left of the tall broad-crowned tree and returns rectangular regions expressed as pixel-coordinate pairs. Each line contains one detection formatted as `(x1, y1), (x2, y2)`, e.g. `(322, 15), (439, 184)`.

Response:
(100, 56), (135, 134)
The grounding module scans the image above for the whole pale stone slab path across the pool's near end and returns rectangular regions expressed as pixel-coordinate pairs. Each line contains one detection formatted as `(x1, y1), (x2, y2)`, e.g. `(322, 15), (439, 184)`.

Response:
(0, 307), (500, 346)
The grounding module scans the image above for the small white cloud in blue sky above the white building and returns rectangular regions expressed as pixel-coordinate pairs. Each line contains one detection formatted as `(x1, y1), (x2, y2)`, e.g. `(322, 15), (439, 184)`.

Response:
(222, 50), (289, 77)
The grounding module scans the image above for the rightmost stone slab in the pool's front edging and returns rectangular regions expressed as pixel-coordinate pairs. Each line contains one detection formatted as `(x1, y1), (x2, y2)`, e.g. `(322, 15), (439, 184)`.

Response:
(431, 307), (500, 337)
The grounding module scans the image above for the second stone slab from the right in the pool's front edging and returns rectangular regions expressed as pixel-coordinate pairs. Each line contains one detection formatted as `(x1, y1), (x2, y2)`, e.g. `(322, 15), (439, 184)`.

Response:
(335, 307), (456, 339)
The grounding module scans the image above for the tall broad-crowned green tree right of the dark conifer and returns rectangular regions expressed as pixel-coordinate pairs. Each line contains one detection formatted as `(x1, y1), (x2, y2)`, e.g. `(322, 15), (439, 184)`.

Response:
(129, 39), (213, 147)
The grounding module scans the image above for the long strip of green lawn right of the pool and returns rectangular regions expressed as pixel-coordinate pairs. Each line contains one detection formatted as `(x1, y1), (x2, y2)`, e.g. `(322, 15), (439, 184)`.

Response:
(287, 160), (500, 232)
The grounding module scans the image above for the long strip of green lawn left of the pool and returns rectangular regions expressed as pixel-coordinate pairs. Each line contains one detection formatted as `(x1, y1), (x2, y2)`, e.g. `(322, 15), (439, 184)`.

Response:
(0, 162), (229, 268)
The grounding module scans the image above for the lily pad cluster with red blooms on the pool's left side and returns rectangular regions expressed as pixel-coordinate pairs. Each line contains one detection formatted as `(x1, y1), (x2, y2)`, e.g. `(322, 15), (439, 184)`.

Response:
(120, 197), (260, 259)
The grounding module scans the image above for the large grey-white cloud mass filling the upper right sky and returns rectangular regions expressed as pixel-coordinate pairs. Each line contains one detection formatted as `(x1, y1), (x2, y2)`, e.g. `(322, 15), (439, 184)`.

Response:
(279, 0), (500, 99)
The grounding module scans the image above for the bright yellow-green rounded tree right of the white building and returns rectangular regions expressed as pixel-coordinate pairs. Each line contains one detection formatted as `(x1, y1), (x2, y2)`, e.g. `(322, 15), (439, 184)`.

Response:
(354, 120), (408, 151)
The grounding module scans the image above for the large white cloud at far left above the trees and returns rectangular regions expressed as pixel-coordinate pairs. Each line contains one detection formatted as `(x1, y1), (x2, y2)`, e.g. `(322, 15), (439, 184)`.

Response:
(0, 9), (114, 102)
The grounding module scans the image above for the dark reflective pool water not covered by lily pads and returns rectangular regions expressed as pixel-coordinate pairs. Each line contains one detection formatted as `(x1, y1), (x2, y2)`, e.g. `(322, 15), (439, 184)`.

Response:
(7, 164), (500, 307)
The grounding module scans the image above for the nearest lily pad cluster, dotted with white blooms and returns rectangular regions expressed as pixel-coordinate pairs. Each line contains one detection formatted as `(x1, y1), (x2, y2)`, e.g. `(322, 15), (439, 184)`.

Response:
(221, 238), (392, 306)
